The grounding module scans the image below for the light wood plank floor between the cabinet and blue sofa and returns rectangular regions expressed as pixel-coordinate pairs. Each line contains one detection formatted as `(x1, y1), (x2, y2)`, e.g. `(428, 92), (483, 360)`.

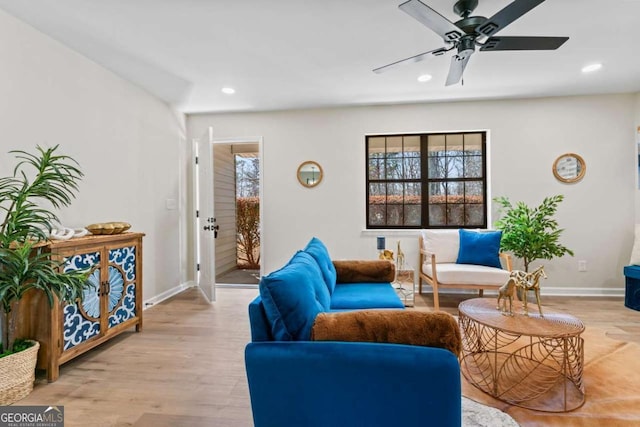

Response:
(17, 288), (640, 427)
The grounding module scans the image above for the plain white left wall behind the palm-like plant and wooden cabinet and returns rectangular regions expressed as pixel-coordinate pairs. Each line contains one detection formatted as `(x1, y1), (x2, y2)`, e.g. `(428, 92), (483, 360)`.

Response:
(0, 12), (186, 299)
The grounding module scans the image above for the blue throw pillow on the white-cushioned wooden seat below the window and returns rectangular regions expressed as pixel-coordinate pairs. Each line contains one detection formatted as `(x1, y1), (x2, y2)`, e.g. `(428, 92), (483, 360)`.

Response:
(456, 228), (502, 268)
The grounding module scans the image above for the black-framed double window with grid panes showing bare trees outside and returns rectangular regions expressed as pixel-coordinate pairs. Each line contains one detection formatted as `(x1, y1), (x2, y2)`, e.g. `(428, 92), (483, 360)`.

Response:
(366, 132), (487, 228)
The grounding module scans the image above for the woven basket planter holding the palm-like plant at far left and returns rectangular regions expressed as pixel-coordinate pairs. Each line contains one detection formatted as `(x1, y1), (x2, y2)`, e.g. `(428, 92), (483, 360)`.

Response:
(0, 341), (40, 406)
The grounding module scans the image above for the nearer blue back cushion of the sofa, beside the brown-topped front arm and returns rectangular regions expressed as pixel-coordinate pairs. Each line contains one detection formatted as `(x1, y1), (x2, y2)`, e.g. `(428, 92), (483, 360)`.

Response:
(259, 251), (331, 341)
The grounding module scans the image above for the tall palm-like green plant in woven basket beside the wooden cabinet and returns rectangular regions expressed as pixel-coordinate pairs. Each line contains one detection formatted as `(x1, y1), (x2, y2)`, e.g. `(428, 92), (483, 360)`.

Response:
(0, 146), (88, 405)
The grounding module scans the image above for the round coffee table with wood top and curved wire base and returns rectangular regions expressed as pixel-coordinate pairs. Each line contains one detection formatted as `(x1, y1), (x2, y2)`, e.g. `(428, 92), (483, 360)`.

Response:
(458, 298), (584, 412)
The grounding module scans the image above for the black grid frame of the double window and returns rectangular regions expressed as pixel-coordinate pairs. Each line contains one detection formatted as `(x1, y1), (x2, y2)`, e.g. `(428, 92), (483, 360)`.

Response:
(365, 130), (489, 230)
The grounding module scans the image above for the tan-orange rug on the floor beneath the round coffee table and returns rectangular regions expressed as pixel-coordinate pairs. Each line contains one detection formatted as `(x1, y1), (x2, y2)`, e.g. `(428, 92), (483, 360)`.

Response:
(462, 327), (640, 427)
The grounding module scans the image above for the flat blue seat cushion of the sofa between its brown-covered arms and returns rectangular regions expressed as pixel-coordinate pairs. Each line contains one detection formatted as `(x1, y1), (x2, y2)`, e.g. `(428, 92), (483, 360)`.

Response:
(331, 282), (404, 311)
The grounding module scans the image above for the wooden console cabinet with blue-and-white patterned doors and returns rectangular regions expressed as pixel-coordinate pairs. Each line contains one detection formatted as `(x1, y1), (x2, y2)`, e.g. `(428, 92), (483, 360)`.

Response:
(18, 233), (144, 381)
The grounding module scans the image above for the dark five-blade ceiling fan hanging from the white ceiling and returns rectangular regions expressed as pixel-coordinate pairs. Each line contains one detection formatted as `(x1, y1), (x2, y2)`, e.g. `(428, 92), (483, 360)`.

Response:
(373, 0), (569, 86)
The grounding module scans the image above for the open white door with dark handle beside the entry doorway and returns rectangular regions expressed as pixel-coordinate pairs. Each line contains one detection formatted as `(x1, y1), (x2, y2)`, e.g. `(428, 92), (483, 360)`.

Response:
(193, 127), (216, 302)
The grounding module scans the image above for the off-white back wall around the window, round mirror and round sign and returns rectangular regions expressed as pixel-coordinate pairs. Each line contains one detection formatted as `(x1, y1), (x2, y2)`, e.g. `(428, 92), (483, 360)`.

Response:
(187, 94), (638, 294)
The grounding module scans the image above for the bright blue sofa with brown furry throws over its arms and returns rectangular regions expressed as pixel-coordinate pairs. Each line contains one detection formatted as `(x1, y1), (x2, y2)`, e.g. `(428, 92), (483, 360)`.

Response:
(245, 238), (461, 427)
